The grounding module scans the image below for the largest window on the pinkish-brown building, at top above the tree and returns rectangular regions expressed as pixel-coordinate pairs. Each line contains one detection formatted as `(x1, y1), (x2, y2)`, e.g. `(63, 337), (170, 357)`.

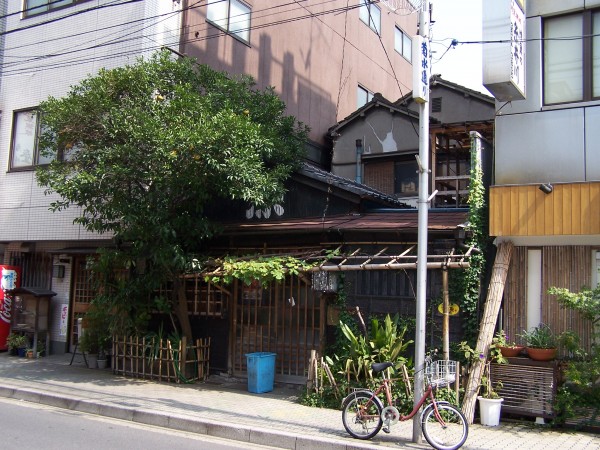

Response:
(206, 0), (251, 42)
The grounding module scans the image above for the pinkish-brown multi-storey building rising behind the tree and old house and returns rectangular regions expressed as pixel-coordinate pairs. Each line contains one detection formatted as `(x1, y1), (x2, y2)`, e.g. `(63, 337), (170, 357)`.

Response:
(180, 0), (418, 166)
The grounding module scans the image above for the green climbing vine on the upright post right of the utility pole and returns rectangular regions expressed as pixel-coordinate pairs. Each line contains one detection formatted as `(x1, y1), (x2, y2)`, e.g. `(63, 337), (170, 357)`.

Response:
(450, 138), (490, 343)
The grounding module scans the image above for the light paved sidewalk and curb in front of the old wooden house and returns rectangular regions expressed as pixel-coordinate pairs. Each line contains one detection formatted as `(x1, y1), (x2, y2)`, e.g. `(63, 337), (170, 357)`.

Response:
(0, 353), (600, 450)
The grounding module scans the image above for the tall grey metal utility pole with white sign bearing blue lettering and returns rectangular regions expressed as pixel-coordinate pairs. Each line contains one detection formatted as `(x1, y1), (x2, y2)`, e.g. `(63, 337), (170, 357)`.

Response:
(413, 0), (431, 443)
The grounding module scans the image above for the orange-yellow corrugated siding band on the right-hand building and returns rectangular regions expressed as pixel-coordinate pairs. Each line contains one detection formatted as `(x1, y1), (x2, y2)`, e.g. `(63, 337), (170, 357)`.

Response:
(490, 182), (600, 236)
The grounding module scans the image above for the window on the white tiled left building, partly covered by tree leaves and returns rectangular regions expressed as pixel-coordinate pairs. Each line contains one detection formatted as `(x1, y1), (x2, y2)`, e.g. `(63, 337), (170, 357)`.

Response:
(10, 109), (61, 169)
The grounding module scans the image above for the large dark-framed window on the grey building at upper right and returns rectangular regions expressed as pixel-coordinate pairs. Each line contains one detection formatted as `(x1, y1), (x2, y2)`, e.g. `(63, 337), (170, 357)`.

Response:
(544, 11), (600, 104)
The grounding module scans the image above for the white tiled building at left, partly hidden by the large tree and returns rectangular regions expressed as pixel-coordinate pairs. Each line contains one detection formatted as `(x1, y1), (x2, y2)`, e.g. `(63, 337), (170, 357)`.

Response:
(0, 0), (181, 352)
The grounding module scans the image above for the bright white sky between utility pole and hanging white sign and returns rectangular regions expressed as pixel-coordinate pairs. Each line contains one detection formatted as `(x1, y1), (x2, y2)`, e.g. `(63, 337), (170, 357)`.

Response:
(431, 0), (490, 95)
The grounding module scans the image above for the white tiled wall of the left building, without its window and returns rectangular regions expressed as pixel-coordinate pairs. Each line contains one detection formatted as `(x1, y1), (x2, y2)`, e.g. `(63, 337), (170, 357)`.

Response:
(0, 0), (182, 352)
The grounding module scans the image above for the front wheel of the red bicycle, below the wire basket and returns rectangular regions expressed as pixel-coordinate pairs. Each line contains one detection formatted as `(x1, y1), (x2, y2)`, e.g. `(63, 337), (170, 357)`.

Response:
(421, 403), (469, 450)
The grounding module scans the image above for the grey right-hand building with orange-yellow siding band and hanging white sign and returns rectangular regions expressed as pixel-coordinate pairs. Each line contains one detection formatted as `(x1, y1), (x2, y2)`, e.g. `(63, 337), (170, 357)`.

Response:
(483, 0), (600, 352)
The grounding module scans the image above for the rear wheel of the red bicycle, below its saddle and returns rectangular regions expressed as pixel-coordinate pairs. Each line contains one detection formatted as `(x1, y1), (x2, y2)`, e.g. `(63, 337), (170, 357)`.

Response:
(342, 392), (383, 439)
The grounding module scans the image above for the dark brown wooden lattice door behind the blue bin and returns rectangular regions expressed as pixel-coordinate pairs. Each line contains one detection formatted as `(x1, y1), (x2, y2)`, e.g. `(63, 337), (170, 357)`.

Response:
(233, 276), (324, 381)
